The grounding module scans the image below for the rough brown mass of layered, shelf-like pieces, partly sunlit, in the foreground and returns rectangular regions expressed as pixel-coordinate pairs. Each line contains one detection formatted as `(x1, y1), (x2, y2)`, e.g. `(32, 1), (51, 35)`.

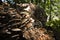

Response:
(0, 3), (55, 40)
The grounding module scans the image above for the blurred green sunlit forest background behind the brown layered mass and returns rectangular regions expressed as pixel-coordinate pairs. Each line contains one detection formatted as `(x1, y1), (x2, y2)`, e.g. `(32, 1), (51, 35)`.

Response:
(2, 0), (60, 40)
